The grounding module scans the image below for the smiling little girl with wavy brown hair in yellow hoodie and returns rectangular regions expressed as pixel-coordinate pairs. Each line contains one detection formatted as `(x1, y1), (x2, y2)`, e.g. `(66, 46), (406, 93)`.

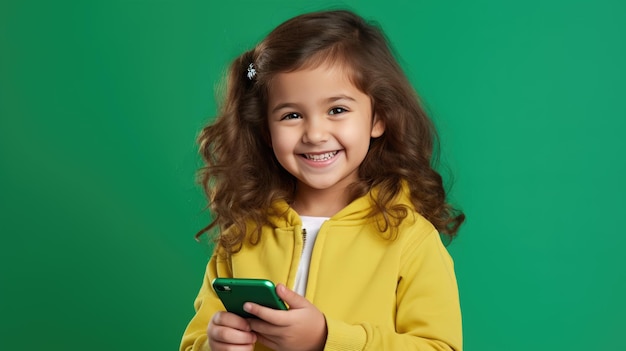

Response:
(180, 11), (464, 351)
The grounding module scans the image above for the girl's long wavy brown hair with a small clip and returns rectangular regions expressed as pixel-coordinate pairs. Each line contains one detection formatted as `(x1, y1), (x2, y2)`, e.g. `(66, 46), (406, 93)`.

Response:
(196, 10), (465, 253)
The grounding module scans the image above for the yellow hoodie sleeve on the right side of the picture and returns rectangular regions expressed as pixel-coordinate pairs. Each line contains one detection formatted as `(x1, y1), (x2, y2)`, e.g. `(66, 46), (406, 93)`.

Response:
(324, 231), (463, 351)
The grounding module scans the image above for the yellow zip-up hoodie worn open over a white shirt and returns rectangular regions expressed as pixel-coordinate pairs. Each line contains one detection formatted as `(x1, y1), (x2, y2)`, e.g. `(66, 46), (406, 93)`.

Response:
(180, 190), (462, 351)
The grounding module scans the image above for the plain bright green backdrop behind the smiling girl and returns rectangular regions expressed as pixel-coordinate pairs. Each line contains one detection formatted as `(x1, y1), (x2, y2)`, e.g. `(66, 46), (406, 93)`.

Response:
(0, 0), (626, 351)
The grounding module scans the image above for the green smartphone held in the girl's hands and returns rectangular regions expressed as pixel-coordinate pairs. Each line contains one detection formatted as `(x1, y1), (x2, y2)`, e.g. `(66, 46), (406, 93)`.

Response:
(211, 278), (287, 318)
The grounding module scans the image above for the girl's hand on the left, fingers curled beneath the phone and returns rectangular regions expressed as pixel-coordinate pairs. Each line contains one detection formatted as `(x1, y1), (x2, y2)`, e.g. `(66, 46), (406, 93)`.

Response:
(207, 312), (257, 351)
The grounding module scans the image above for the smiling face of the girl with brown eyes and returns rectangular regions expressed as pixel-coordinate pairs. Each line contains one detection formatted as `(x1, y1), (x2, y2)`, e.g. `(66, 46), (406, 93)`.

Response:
(268, 64), (384, 208)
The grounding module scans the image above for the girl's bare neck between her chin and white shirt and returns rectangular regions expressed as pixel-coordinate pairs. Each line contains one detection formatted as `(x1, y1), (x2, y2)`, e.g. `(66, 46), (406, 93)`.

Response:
(292, 187), (349, 217)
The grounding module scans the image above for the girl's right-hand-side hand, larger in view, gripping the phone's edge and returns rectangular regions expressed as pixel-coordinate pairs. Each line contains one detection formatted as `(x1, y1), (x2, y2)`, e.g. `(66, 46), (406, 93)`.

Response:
(244, 284), (327, 351)
